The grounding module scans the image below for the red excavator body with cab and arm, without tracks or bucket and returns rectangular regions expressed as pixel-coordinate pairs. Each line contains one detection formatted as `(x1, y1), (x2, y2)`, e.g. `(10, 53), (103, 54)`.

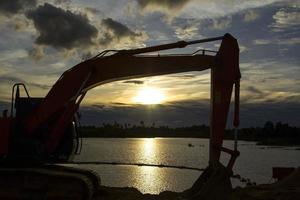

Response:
(0, 34), (241, 199)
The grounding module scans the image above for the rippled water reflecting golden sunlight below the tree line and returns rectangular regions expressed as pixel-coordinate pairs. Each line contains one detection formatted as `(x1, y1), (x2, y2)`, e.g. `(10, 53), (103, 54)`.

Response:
(74, 138), (300, 194)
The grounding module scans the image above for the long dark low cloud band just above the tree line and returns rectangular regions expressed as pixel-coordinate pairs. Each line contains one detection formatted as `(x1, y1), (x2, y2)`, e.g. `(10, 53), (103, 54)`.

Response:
(80, 99), (300, 127)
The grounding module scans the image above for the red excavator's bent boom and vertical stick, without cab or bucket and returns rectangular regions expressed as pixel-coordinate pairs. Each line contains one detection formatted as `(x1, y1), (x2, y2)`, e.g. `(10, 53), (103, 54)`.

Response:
(25, 34), (240, 166)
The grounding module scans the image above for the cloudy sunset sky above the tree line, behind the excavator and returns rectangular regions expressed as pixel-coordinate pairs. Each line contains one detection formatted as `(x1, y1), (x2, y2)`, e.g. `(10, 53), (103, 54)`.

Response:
(0, 0), (300, 127)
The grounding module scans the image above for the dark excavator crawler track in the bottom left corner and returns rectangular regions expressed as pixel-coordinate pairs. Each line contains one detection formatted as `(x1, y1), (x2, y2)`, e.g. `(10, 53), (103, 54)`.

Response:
(0, 165), (100, 200)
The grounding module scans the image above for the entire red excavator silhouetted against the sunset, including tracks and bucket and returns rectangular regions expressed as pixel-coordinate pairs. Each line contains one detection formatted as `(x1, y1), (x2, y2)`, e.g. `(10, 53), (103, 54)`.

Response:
(0, 33), (241, 199)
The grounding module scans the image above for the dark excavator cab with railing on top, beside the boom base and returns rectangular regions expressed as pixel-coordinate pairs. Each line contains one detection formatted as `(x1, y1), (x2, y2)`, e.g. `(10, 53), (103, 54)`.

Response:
(5, 83), (79, 163)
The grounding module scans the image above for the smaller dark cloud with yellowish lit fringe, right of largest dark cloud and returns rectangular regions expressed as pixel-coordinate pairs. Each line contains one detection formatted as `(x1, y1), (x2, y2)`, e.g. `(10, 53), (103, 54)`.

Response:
(99, 18), (148, 47)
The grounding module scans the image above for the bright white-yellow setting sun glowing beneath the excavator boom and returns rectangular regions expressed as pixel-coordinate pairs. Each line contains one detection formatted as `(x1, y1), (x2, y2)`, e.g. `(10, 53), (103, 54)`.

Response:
(133, 87), (165, 104)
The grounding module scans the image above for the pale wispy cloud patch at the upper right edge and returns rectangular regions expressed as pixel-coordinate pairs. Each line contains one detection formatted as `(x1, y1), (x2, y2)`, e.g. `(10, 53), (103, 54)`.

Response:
(271, 8), (300, 31)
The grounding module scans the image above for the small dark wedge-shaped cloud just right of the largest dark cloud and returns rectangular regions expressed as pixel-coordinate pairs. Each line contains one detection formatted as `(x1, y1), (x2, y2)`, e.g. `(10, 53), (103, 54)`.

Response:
(100, 18), (142, 45)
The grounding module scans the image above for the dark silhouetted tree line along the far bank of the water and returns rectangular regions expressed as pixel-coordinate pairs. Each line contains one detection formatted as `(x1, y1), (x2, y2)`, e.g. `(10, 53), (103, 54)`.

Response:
(80, 121), (300, 145)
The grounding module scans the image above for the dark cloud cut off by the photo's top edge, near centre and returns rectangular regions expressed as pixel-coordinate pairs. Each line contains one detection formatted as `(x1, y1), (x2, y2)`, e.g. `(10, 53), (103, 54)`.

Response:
(137, 0), (189, 10)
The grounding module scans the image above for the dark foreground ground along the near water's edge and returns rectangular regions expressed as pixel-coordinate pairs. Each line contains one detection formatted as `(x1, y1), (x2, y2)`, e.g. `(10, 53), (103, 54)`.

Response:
(93, 167), (300, 200)
